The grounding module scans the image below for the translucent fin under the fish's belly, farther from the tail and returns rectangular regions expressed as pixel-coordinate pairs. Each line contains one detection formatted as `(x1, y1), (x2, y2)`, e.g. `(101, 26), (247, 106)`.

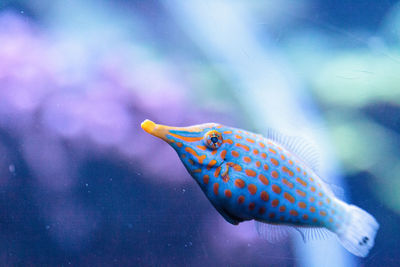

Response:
(255, 221), (293, 243)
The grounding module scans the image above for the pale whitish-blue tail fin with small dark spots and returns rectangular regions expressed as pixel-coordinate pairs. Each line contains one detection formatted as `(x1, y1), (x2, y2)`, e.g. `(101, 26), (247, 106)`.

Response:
(337, 205), (379, 257)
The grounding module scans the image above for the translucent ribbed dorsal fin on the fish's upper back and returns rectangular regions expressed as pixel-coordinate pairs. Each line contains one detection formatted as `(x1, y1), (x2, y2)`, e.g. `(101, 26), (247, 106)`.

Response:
(266, 129), (319, 172)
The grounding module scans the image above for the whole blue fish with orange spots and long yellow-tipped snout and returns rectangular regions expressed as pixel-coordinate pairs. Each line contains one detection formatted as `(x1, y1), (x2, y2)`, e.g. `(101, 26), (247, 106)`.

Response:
(141, 120), (379, 257)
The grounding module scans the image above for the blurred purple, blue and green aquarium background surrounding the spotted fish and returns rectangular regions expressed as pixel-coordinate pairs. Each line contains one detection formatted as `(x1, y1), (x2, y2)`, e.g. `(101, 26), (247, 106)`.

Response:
(0, 0), (400, 266)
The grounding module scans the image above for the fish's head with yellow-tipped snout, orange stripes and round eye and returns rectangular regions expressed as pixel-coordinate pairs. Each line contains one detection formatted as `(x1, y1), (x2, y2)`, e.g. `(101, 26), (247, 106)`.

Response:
(141, 120), (233, 176)
